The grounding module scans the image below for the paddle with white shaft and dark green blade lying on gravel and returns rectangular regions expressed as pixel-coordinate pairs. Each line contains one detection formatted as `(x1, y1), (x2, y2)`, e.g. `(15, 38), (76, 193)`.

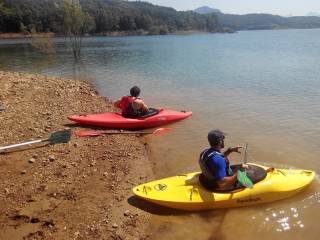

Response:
(0, 130), (71, 152)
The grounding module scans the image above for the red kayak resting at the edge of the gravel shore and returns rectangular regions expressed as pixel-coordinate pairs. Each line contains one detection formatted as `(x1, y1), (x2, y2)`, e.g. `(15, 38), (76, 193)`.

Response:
(68, 109), (192, 129)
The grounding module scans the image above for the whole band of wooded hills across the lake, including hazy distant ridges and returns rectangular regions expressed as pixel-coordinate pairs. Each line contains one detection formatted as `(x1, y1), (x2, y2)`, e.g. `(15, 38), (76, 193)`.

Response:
(0, 0), (320, 34)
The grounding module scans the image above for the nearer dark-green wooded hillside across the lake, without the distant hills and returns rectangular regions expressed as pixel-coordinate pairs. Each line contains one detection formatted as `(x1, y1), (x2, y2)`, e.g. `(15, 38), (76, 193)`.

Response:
(0, 0), (219, 34)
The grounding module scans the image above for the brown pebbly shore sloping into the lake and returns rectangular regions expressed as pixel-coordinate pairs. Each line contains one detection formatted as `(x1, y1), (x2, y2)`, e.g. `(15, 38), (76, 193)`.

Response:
(0, 71), (153, 240)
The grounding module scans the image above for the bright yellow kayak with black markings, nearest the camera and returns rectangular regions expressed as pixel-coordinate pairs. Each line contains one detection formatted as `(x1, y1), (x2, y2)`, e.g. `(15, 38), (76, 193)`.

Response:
(133, 164), (315, 211)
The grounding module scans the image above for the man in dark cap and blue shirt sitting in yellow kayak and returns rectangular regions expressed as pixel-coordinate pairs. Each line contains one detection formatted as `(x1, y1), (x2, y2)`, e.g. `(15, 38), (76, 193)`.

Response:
(199, 129), (246, 190)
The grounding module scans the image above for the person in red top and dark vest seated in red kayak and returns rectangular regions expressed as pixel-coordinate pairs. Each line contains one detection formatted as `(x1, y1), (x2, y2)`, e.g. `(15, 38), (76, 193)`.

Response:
(114, 86), (149, 118)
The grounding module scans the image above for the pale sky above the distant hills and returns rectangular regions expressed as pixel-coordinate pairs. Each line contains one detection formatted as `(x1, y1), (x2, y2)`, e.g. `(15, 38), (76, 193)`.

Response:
(144, 0), (320, 16)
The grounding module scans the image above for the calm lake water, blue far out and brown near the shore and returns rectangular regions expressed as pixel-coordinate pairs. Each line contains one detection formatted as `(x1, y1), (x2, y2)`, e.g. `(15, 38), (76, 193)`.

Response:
(0, 29), (320, 240)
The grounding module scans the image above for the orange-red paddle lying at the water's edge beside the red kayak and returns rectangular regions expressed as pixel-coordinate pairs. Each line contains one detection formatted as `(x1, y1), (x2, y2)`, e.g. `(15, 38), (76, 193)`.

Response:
(74, 128), (171, 137)
